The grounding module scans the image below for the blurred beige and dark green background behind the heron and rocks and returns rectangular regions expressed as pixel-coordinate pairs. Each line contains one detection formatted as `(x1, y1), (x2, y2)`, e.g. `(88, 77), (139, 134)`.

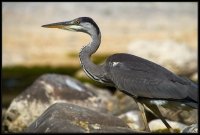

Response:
(2, 2), (198, 107)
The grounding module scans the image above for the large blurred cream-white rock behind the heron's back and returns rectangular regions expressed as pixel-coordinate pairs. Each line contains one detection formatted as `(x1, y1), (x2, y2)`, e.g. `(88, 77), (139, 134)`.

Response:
(127, 40), (197, 75)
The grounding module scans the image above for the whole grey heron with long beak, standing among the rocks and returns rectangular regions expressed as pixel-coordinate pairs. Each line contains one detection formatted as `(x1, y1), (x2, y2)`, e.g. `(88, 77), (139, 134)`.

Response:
(42, 17), (198, 130)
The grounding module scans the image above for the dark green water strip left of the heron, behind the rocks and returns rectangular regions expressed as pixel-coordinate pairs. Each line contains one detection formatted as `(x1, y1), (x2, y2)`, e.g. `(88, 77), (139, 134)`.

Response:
(2, 66), (80, 107)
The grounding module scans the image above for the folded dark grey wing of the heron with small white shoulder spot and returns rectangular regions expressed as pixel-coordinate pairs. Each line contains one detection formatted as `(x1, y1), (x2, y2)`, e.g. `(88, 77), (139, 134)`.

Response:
(106, 54), (195, 99)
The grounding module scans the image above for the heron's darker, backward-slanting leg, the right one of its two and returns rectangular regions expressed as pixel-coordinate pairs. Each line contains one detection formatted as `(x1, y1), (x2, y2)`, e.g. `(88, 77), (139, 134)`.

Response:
(144, 103), (173, 132)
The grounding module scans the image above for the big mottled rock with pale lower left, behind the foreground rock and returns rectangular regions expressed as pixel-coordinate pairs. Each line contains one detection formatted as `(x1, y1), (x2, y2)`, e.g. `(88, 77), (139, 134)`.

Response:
(3, 74), (112, 132)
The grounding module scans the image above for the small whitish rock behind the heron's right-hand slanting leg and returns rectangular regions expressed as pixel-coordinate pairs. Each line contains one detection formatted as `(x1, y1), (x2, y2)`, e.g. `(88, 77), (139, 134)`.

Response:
(148, 119), (187, 132)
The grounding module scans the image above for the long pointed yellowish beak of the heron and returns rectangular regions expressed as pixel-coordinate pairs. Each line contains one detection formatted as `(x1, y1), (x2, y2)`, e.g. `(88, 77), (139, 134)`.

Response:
(42, 21), (71, 29)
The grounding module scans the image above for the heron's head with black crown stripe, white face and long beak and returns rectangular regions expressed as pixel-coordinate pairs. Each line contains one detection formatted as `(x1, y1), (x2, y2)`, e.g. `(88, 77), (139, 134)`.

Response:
(42, 17), (100, 34)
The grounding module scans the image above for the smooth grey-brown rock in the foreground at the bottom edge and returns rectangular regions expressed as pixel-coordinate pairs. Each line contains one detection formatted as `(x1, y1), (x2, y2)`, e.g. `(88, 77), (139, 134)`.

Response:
(25, 103), (139, 133)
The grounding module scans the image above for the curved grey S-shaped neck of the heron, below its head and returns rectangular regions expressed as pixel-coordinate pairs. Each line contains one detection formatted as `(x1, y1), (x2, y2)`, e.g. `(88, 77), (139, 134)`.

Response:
(79, 33), (103, 81)
